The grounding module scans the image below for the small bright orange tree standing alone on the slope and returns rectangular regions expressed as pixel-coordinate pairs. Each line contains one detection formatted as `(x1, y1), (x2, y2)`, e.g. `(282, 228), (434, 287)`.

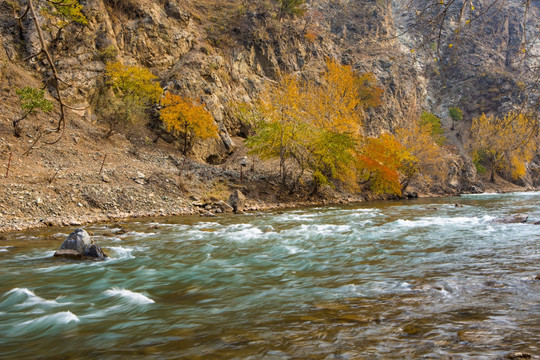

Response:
(160, 92), (218, 156)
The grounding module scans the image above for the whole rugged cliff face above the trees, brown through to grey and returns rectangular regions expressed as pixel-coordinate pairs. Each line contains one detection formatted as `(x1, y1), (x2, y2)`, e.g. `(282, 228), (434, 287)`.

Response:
(0, 0), (539, 188)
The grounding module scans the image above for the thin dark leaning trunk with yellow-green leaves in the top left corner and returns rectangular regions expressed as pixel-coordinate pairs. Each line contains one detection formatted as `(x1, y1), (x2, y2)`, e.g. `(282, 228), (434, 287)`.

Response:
(14, 0), (88, 151)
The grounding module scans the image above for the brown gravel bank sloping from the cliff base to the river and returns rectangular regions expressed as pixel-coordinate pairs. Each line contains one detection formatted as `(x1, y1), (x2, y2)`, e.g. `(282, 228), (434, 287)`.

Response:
(0, 115), (532, 233)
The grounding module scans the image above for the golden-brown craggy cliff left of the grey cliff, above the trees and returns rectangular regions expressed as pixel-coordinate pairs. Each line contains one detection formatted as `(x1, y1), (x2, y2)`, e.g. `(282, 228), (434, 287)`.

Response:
(1, 0), (425, 155)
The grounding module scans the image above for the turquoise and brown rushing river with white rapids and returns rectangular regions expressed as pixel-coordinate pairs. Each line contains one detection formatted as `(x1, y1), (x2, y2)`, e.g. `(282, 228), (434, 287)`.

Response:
(0, 193), (540, 359)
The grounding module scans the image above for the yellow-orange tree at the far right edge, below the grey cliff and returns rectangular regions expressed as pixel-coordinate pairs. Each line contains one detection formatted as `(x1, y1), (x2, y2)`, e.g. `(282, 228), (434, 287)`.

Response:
(471, 113), (538, 182)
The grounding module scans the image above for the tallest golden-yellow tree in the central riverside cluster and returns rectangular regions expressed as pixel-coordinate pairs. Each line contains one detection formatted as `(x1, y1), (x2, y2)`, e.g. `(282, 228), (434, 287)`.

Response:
(302, 60), (382, 191)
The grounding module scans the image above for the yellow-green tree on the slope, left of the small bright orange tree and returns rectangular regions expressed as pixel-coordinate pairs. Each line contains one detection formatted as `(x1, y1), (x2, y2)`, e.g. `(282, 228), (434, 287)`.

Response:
(95, 62), (163, 137)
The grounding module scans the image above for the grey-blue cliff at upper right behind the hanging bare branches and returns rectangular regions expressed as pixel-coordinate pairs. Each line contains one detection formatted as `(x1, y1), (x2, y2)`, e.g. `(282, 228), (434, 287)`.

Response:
(394, 0), (540, 120)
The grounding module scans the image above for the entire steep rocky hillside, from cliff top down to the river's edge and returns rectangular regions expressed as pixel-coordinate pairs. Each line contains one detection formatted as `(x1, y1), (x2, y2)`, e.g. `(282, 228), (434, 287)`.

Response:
(0, 0), (536, 229)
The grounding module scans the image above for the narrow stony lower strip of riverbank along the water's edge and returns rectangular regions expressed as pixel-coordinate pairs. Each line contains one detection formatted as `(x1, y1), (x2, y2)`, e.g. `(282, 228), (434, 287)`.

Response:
(0, 163), (538, 233)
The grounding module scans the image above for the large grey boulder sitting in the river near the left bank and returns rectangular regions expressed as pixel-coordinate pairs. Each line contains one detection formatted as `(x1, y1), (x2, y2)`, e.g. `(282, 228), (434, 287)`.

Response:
(54, 229), (107, 260)
